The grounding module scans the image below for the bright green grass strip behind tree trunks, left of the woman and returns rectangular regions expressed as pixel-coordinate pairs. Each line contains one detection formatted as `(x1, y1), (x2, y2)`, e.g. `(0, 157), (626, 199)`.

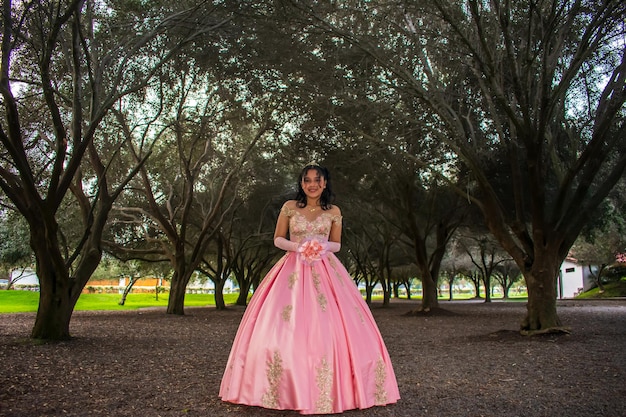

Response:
(0, 290), (237, 313)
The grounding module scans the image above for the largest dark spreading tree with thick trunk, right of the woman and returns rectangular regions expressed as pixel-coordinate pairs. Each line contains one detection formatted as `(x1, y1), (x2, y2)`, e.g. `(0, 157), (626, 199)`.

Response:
(296, 0), (626, 333)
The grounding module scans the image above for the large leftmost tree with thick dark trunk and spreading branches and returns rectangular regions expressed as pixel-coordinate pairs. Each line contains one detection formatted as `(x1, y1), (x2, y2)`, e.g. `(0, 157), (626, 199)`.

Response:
(0, 0), (229, 340)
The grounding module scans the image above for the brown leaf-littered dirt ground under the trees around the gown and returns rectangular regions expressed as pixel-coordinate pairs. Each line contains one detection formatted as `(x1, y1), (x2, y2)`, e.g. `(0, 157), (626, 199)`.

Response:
(0, 300), (626, 417)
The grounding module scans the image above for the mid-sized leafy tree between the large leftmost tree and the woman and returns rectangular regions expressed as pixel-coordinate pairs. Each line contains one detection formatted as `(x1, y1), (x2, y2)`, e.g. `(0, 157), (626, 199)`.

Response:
(103, 61), (281, 315)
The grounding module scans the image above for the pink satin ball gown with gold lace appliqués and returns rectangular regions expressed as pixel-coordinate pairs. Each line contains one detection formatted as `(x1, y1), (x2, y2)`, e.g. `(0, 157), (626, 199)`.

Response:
(219, 207), (400, 414)
